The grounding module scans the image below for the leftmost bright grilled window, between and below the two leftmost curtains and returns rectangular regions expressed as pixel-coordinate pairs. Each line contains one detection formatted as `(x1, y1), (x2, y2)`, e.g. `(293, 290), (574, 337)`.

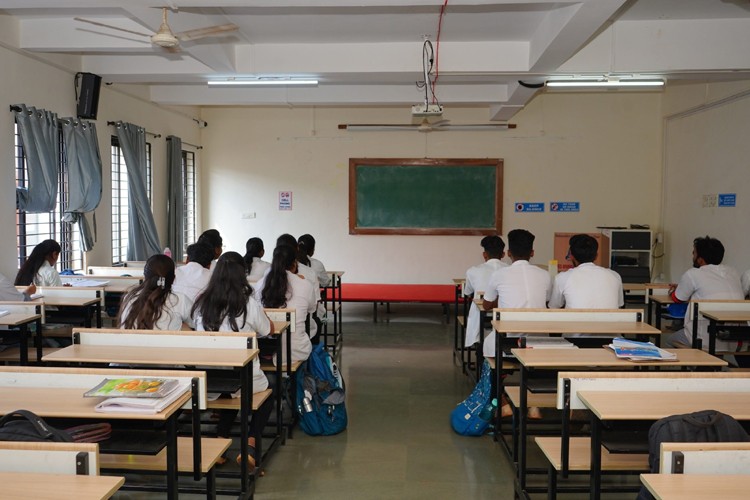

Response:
(14, 126), (83, 271)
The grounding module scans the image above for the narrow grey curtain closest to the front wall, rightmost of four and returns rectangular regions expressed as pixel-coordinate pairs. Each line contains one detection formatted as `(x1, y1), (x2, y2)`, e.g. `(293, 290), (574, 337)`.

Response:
(167, 135), (185, 260)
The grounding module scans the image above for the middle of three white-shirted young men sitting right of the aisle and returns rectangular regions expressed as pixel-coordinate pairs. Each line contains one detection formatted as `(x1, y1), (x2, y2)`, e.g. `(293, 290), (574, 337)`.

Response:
(482, 229), (552, 419)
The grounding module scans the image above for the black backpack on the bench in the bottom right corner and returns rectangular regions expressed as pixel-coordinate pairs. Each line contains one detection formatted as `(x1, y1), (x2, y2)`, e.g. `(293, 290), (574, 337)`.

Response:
(638, 410), (750, 500)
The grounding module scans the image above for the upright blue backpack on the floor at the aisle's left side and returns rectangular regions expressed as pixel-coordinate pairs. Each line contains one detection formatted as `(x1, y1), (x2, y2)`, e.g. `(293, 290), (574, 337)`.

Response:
(296, 344), (347, 436)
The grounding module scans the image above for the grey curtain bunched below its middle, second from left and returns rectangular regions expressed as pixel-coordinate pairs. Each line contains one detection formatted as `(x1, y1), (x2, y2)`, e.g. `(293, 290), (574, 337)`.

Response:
(62, 118), (102, 252)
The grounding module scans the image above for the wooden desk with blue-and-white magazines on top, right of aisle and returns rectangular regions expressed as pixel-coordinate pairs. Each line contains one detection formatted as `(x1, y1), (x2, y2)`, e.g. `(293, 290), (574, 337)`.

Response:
(511, 348), (728, 488)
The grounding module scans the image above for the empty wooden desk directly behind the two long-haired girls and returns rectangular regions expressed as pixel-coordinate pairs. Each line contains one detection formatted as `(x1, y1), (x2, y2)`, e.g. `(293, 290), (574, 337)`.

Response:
(45, 340), (260, 493)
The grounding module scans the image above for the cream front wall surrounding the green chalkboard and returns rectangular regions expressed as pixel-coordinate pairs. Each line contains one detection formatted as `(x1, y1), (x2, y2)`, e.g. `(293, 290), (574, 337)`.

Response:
(201, 93), (662, 283)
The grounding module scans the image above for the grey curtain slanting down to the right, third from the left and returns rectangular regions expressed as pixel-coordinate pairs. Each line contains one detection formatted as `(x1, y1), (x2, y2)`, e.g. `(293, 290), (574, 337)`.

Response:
(117, 122), (161, 260)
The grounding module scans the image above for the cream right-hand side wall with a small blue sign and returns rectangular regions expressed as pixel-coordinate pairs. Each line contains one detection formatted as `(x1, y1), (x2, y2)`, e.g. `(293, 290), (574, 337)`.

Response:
(662, 81), (750, 281)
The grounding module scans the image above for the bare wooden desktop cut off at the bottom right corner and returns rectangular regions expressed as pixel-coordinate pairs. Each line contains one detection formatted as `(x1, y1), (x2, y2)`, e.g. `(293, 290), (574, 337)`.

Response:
(641, 474), (750, 500)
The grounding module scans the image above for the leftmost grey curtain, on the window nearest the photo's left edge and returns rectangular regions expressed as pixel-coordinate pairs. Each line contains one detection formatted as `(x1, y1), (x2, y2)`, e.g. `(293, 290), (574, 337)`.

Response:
(12, 104), (60, 213)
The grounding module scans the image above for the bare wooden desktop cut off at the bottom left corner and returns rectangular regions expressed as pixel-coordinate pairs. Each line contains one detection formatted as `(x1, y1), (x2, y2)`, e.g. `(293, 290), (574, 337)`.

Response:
(0, 472), (125, 500)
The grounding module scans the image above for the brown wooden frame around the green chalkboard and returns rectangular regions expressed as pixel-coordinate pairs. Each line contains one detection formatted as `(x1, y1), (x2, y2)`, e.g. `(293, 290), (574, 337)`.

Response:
(349, 158), (503, 236)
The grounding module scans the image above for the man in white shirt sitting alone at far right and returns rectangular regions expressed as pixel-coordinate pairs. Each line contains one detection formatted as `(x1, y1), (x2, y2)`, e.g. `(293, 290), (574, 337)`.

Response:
(667, 236), (745, 351)
